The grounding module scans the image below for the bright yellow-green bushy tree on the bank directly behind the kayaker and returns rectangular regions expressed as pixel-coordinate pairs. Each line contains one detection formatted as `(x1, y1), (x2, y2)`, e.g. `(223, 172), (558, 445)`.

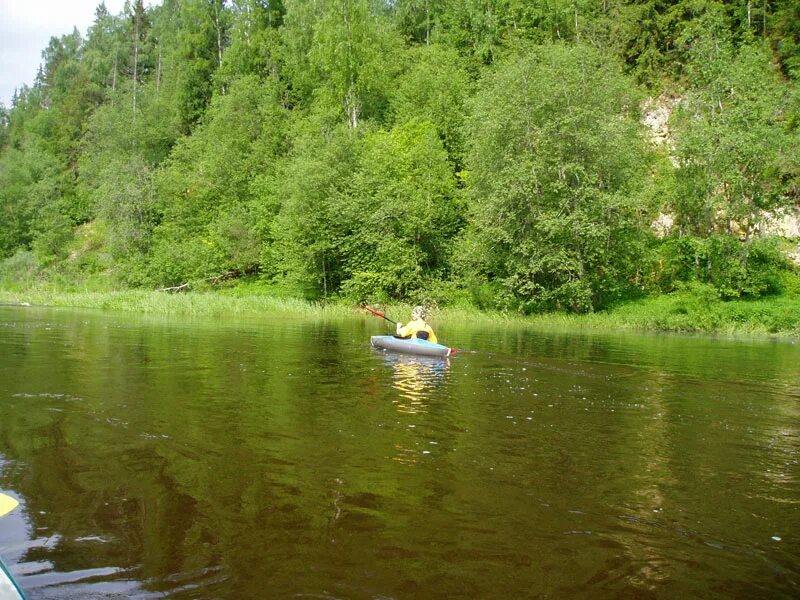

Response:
(339, 120), (462, 300)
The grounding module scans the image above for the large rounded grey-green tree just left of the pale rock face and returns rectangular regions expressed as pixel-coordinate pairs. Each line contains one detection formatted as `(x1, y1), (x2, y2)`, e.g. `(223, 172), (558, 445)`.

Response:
(465, 44), (648, 312)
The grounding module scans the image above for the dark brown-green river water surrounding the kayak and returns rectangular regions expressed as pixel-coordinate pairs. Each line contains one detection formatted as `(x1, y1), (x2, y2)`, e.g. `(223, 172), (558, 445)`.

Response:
(0, 307), (800, 599)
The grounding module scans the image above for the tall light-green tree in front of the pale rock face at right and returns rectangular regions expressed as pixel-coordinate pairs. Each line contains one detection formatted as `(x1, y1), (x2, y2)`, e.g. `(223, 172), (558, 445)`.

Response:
(674, 15), (798, 296)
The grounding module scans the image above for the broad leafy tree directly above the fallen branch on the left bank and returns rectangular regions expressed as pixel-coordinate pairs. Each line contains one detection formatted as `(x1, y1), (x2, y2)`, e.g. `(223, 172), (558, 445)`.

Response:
(148, 75), (286, 285)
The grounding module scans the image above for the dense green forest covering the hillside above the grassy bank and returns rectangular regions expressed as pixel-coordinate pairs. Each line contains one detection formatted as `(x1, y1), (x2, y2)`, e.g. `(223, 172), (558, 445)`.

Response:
(0, 0), (800, 314)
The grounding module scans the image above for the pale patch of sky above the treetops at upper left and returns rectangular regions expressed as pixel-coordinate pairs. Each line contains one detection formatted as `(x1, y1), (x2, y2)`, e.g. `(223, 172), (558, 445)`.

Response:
(0, 0), (129, 108)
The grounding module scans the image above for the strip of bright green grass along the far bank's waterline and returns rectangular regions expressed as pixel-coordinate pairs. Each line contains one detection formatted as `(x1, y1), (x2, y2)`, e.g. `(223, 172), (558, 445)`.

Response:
(0, 286), (800, 338)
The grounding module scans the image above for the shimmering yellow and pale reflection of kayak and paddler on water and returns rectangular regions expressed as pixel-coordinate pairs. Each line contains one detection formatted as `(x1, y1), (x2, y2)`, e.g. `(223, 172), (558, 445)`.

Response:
(382, 350), (450, 414)
